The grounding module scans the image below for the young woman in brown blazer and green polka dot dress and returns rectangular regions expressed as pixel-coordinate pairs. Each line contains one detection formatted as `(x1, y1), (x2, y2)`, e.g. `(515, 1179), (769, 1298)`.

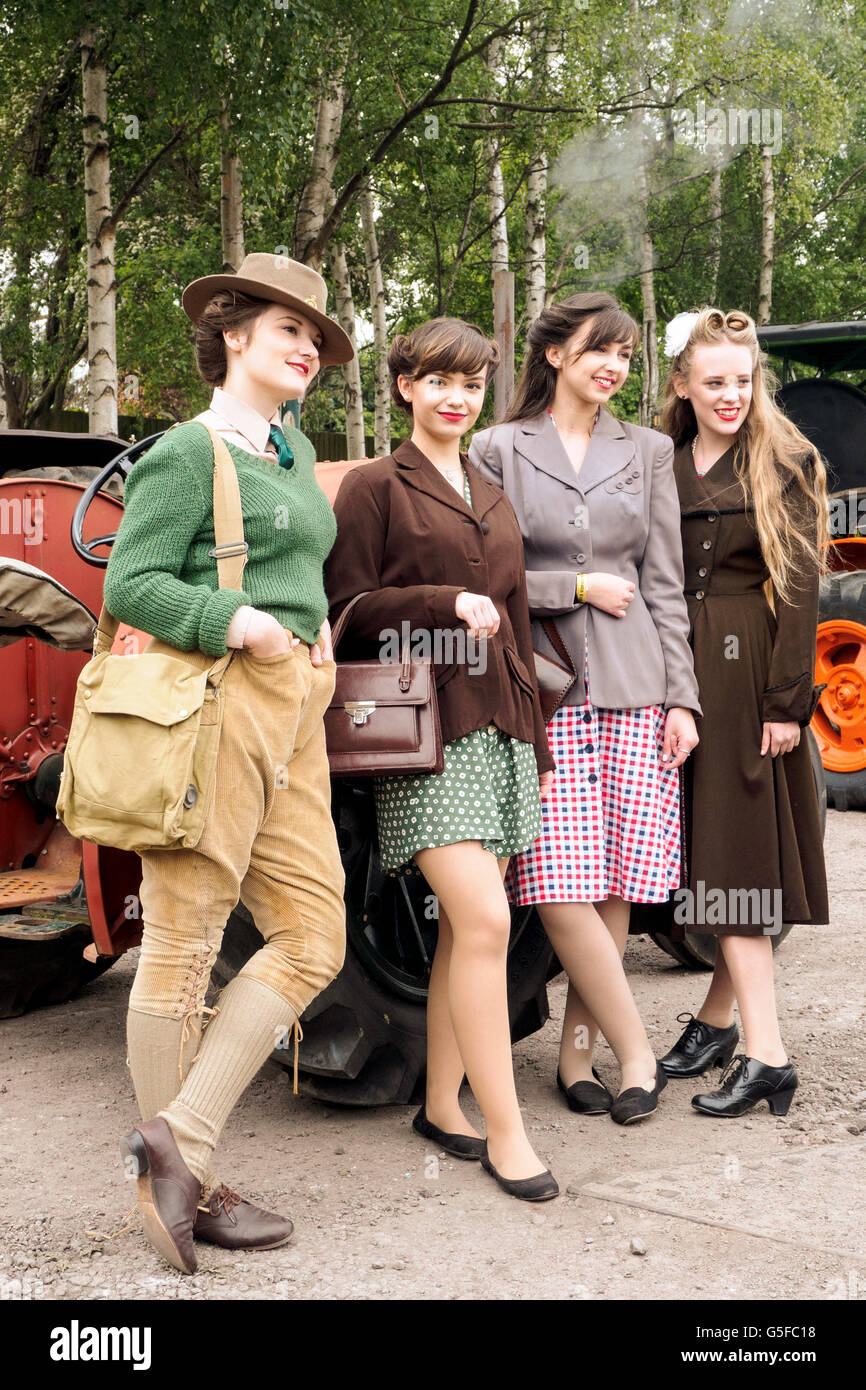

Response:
(325, 318), (559, 1201)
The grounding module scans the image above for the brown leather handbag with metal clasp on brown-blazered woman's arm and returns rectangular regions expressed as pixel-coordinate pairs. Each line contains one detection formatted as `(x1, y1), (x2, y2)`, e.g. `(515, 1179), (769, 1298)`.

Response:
(325, 589), (445, 777)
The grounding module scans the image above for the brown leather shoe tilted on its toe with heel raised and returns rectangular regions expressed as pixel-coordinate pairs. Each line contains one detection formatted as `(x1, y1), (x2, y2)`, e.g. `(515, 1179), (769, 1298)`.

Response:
(121, 1116), (202, 1275)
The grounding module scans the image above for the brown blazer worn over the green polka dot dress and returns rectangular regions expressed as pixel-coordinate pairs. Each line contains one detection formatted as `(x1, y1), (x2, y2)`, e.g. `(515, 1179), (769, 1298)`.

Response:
(325, 439), (556, 773)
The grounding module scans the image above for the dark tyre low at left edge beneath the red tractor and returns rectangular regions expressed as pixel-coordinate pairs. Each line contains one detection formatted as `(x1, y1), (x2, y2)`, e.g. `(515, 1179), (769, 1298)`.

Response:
(0, 930), (115, 1019)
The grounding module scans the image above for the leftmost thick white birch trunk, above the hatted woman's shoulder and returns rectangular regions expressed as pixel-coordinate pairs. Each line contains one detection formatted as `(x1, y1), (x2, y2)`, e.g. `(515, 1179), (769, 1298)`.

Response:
(81, 26), (117, 434)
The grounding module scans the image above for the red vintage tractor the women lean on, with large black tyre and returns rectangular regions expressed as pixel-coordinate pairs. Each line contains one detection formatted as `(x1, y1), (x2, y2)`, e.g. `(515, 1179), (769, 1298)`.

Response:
(0, 431), (559, 1105)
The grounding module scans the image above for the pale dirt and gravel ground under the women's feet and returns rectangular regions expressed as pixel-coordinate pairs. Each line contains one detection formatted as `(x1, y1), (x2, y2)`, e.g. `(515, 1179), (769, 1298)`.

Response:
(0, 812), (866, 1300)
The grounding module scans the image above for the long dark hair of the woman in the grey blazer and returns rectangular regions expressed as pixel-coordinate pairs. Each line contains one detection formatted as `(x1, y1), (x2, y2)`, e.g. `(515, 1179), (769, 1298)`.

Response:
(505, 291), (641, 423)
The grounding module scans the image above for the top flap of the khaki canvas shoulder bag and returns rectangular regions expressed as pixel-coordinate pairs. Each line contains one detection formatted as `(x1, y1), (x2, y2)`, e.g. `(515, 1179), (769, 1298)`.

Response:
(78, 652), (207, 727)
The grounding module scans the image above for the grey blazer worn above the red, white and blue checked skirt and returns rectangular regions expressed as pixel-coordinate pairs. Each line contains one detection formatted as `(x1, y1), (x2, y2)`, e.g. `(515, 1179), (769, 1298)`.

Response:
(468, 409), (701, 714)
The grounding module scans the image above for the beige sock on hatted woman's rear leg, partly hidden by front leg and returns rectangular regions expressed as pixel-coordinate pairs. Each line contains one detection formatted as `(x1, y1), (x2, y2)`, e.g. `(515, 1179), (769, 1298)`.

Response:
(126, 1009), (220, 1200)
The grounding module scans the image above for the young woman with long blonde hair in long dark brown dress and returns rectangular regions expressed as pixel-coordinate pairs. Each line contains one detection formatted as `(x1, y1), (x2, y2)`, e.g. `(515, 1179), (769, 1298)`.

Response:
(647, 309), (828, 1116)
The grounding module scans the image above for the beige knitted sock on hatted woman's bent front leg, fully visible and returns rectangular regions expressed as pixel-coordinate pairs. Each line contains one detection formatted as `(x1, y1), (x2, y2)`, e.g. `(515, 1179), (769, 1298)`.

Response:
(160, 974), (297, 1182)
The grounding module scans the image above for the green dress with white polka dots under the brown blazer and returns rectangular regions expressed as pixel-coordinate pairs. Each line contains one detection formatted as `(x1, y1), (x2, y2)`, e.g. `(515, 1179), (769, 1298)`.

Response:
(374, 471), (541, 874)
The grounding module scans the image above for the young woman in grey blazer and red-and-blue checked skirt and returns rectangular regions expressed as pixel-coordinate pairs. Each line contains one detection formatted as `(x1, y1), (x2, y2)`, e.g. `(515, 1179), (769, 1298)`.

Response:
(470, 293), (701, 1123)
